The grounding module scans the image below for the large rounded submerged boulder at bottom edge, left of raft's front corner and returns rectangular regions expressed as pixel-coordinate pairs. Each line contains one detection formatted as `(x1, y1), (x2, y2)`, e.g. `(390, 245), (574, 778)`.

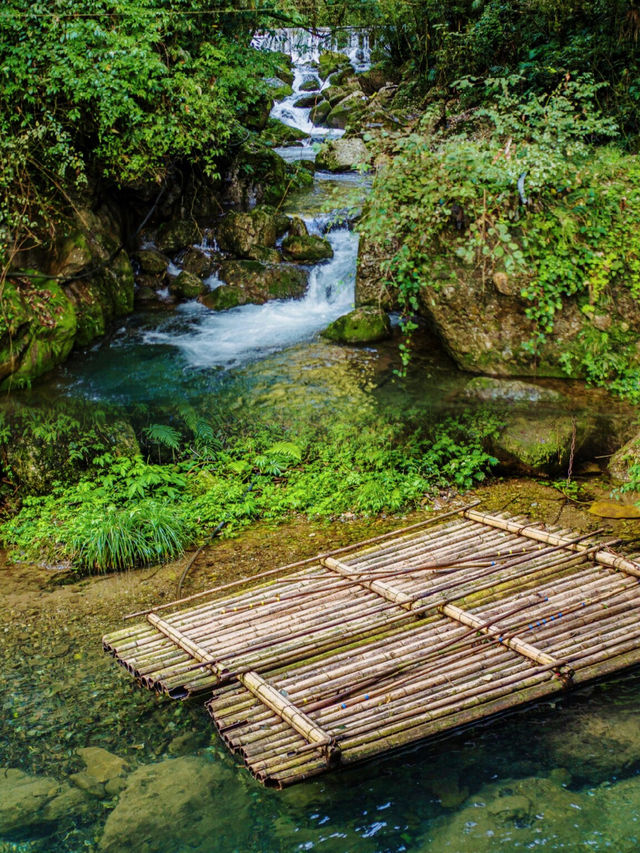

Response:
(98, 756), (251, 853)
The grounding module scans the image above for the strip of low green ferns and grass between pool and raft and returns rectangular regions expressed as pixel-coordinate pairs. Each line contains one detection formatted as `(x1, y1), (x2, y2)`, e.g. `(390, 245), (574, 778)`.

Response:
(2, 414), (496, 571)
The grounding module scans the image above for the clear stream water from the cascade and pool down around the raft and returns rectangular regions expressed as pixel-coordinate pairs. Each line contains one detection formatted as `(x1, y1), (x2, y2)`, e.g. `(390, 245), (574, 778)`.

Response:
(0, 26), (640, 853)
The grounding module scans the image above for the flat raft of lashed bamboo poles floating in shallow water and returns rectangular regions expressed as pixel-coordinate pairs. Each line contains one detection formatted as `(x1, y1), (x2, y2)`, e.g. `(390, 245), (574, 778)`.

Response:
(103, 505), (640, 787)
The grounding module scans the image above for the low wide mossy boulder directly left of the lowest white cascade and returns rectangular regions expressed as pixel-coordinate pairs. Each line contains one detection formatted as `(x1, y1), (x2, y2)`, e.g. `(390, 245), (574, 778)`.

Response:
(200, 261), (309, 311)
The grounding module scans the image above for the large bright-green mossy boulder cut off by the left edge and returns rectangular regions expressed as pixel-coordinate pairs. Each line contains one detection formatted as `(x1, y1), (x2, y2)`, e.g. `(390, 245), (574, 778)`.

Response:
(0, 273), (78, 389)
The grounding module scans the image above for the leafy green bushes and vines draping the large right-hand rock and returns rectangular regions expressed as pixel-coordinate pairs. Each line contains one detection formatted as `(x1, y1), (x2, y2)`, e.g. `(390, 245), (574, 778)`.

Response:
(362, 71), (640, 399)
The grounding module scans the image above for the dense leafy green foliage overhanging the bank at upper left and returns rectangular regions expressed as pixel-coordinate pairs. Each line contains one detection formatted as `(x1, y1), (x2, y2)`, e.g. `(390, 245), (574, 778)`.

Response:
(0, 0), (280, 262)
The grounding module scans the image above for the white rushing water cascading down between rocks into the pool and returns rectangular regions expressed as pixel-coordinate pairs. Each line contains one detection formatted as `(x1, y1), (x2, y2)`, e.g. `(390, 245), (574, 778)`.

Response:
(143, 31), (369, 368)
